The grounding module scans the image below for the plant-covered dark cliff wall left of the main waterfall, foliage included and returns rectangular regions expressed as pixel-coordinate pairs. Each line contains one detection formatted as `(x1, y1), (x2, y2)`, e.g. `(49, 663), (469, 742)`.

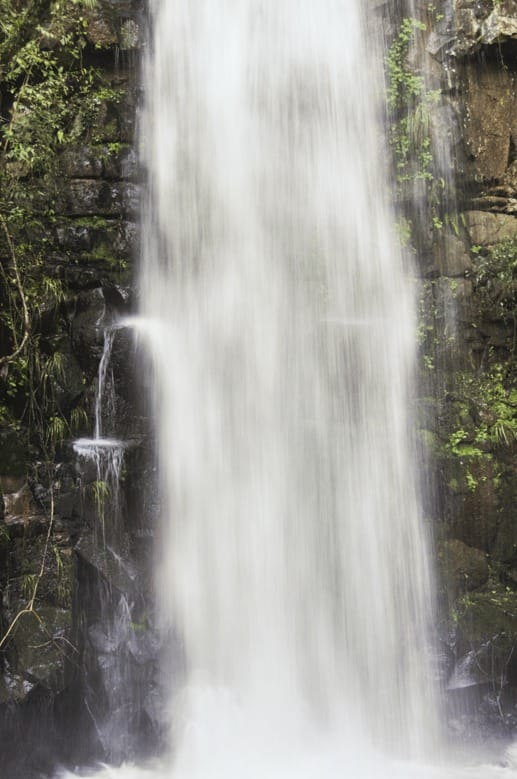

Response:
(0, 0), (145, 779)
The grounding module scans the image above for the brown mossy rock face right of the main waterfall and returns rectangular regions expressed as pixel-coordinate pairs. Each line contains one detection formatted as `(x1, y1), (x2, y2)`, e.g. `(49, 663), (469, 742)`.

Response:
(400, 0), (517, 737)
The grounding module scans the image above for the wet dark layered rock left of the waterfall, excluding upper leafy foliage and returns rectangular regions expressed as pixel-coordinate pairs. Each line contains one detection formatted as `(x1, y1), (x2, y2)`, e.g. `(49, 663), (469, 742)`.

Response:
(0, 0), (158, 779)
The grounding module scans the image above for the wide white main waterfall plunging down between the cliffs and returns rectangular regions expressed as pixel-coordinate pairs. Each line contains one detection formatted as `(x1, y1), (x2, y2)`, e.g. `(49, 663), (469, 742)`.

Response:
(61, 0), (511, 779)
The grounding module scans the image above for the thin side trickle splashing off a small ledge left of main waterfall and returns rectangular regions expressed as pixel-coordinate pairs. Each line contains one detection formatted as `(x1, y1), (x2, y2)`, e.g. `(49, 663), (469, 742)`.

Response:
(74, 317), (157, 763)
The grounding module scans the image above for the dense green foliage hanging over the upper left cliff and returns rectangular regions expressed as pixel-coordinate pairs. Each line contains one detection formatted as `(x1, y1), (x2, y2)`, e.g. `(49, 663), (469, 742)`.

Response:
(0, 0), (120, 459)
